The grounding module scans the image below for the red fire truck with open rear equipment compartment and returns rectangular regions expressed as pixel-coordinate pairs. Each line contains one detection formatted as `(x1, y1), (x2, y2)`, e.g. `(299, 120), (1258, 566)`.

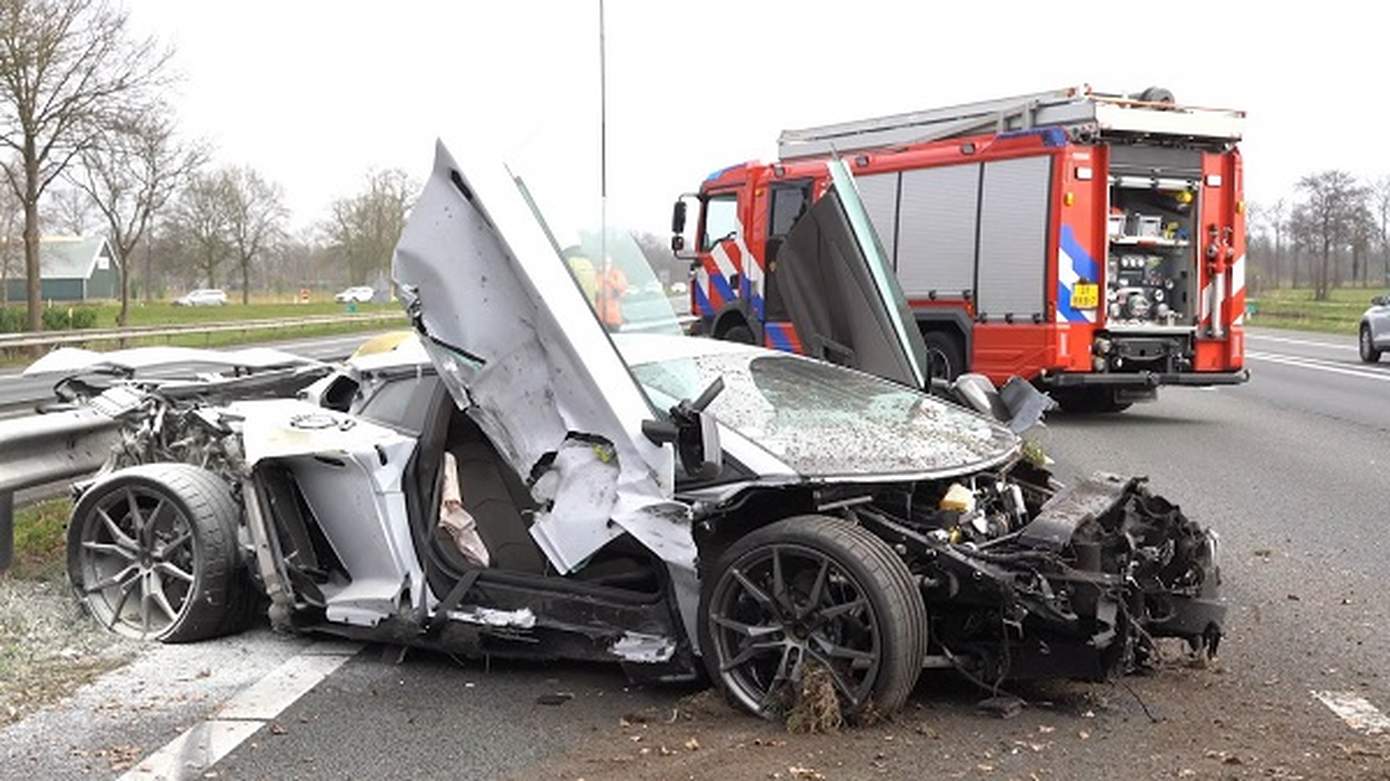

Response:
(673, 86), (1248, 411)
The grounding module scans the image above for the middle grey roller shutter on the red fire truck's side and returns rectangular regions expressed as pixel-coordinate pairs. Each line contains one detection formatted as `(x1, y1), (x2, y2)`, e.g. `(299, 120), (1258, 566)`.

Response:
(898, 163), (980, 299)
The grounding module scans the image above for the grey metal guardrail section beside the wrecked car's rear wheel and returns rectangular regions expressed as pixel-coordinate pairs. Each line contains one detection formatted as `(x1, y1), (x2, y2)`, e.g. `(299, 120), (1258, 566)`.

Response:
(0, 409), (118, 571)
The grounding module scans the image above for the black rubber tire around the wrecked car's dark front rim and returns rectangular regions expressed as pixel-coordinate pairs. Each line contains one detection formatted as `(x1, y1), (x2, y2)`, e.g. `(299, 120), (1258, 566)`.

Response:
(699, 516), (927, 718)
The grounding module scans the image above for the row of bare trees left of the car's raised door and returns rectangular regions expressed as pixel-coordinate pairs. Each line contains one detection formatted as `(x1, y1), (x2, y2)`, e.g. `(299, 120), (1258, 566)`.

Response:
(0, 0), (416, 331)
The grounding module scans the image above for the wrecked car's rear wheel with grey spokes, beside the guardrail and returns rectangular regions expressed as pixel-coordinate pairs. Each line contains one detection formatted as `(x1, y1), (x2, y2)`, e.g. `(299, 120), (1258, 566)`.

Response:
(68, 464), (252, 642)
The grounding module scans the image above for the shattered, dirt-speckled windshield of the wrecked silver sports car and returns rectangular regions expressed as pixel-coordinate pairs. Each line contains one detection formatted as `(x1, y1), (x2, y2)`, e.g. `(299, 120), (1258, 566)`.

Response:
(632, 350), (1016, 478)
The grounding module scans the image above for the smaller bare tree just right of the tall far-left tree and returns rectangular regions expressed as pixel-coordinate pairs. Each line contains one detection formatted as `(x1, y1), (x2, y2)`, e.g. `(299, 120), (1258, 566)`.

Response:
(68, 107), (207, 319)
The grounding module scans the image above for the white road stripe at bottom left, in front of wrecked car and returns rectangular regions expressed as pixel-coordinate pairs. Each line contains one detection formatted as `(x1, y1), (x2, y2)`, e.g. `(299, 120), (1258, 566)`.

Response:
(121, 641), (361, 781)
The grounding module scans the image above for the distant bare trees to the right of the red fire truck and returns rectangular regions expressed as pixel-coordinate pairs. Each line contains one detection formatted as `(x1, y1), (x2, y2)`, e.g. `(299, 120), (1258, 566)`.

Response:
(1247, 170), (1390, 300)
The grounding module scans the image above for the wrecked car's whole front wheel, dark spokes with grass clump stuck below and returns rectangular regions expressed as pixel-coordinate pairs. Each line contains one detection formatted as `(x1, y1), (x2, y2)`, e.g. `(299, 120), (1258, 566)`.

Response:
(699, 516), (927, 718)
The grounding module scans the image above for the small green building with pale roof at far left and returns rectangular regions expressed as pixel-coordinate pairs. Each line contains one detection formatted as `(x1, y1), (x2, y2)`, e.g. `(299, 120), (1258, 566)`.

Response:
(6, 236), (121, 303)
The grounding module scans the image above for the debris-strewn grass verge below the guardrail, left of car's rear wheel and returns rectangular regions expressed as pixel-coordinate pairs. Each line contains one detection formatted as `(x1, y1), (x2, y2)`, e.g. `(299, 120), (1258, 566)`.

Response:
(0, 499), (138, 725)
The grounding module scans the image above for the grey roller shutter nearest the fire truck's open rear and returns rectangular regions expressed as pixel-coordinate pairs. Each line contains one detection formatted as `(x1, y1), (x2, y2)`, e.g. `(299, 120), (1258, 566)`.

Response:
(977, 156), (1052, 322)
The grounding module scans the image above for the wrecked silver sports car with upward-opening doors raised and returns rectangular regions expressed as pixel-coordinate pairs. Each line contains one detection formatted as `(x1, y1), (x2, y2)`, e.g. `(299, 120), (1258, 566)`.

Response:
(16, 146), (1223, 716)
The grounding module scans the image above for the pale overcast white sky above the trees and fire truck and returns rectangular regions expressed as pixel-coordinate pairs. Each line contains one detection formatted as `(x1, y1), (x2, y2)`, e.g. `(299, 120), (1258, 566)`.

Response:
(129, 0), (1390, 233)
